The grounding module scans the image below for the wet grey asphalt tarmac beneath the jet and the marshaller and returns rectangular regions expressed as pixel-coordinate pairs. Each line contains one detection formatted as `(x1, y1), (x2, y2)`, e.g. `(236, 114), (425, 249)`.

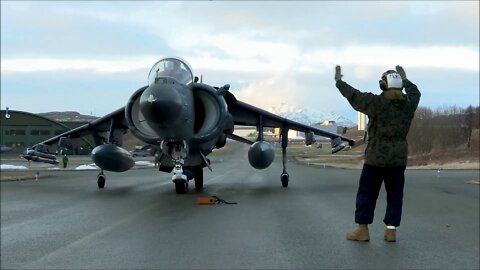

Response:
(1, 147), (480, 269)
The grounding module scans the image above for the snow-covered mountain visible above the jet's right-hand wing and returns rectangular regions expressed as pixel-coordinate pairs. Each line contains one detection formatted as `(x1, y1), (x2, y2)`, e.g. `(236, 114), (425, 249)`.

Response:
(269, 103), (356, 127)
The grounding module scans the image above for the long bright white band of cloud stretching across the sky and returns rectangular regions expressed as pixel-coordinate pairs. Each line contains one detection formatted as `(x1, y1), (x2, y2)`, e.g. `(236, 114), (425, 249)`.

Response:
(1, 44), (479, 76)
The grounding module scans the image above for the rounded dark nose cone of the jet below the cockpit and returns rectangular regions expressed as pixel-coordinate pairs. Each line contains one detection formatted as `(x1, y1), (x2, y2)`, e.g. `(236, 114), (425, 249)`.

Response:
(140, 84), (183, 126)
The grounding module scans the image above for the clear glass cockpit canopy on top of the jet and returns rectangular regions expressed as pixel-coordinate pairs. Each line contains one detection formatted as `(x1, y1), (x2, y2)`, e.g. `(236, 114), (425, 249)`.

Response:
(148, 57), (193, 85)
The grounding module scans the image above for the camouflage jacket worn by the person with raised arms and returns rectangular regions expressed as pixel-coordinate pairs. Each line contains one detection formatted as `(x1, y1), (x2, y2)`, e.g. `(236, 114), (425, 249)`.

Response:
(336, 79), (420, 167)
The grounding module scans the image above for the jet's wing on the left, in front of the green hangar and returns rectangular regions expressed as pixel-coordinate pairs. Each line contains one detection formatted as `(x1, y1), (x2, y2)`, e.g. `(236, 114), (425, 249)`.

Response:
(33, 107), (128, 148)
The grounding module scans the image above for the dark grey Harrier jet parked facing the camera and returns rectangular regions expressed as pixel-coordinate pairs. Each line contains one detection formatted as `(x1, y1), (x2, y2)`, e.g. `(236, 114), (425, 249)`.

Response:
(27, 57), (354, 194)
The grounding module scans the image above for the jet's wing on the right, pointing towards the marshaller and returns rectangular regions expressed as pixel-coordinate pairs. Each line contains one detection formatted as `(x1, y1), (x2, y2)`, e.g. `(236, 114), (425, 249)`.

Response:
(226, 98), (355, 146)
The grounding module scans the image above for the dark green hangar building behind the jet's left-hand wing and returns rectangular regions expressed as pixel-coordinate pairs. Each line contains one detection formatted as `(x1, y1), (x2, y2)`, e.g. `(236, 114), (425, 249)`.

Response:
(0, 108), (95, 154)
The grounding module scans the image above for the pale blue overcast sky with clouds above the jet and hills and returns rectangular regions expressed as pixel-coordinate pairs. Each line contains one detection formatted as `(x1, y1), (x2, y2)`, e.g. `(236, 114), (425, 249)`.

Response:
(1, 1), (479, 120)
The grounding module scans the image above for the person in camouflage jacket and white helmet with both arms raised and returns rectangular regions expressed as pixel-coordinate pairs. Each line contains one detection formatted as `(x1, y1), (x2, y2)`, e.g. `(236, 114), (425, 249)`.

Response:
(335, 66), (420, 242)
